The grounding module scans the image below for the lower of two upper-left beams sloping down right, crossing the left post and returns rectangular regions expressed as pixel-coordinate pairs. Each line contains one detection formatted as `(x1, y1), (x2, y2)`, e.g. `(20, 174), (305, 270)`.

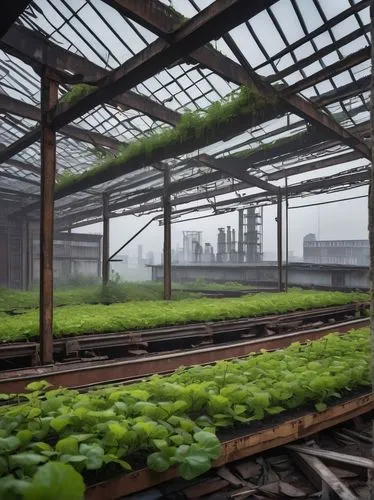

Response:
(0, 94), (122, 150)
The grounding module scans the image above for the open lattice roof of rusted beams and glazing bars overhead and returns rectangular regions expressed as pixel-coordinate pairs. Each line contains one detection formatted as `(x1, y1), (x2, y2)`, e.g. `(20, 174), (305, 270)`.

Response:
(0, 0), (371, 229)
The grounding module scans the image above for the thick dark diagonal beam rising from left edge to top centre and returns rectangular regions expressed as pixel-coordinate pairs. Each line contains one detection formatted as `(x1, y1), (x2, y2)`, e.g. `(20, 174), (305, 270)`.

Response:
(0, 0), (276, 174)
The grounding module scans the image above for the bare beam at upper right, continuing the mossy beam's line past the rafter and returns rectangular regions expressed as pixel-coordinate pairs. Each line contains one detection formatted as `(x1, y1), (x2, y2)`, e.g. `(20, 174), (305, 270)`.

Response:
(284, 47), (370, 95)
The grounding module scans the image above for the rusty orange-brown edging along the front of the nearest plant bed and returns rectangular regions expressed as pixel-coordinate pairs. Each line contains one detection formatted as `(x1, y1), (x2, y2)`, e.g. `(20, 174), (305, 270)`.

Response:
(85, 394), (374, 500)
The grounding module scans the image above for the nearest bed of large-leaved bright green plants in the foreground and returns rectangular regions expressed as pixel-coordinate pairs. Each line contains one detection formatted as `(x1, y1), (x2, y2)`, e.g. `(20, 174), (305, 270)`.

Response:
(0, 329), (370, 500)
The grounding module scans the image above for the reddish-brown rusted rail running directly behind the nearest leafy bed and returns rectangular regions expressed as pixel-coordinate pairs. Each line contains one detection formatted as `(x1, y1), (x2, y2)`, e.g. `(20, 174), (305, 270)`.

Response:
(0, 319), (369, 393)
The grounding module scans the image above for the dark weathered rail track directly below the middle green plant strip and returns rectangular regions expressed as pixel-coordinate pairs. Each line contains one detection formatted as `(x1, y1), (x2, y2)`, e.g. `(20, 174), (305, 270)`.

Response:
(0, 303), (368, 365)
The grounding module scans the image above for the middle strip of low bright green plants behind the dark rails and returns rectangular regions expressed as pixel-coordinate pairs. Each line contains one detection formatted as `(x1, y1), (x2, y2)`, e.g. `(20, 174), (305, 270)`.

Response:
(0, 290), (369, 342)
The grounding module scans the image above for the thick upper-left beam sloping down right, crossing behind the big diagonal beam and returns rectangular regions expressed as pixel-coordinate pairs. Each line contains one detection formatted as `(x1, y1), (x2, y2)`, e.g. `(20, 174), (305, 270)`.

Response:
(0, 26), (180, 125)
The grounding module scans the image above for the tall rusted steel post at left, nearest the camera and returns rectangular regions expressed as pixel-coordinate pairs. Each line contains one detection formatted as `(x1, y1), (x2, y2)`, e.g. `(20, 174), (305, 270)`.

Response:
(39, 73), (58, 364)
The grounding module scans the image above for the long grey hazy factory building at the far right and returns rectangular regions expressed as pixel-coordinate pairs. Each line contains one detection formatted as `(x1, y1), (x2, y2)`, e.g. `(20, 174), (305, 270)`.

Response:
(303, 233), (370, 266)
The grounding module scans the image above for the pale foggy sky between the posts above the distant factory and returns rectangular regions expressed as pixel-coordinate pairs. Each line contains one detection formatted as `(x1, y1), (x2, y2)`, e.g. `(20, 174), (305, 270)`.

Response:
(79, 187), (368, 262)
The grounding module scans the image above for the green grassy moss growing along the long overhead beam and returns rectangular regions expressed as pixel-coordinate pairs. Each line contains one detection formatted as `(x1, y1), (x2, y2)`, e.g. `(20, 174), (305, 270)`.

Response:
(56, 86), (272, 191)
